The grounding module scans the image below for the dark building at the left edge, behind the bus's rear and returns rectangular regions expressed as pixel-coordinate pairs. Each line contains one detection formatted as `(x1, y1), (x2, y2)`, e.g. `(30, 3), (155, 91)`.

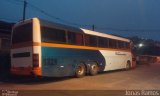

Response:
(0, 21), (13, 79)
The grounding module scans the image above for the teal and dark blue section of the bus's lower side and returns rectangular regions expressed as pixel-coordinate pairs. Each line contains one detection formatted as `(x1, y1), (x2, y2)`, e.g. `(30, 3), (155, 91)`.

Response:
(42, 47), (105, 77)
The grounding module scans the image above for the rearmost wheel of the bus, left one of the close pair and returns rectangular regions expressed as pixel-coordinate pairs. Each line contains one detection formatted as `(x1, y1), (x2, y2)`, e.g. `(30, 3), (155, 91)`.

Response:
(75, 63), (86, 78)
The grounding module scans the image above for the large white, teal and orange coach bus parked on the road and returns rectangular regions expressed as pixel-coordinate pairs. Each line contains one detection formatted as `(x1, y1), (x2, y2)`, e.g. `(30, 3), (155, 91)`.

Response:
(11, 18), (133, 77)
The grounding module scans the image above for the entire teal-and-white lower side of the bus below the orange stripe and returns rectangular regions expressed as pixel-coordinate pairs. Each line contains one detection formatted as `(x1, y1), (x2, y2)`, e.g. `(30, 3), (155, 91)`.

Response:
(42, 47), (131, 77)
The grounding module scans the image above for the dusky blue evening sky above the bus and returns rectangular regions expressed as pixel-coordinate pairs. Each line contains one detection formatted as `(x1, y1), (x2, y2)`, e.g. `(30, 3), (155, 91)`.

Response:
(0, 0), (160, 41)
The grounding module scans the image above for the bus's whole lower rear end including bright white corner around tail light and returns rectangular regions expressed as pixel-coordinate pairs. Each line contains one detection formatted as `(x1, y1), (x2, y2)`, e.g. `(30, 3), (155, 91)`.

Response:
(11, 46), (42, 76)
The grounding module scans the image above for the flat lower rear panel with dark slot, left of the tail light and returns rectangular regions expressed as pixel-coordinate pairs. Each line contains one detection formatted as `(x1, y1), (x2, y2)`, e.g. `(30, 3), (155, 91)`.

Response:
(11, 47), (33, 75)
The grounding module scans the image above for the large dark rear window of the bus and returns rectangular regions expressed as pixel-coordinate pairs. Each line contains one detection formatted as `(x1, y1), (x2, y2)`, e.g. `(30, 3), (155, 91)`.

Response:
(12, 23), (33, 44)
